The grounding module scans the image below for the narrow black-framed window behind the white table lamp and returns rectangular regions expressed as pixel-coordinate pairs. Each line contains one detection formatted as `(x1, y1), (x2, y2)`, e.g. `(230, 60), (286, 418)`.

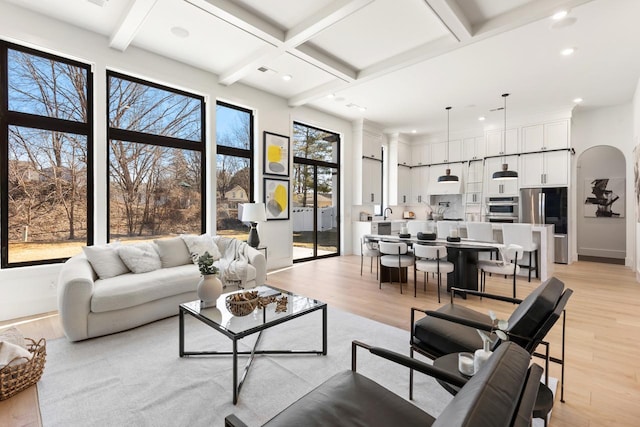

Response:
(216, 102), (254, 240)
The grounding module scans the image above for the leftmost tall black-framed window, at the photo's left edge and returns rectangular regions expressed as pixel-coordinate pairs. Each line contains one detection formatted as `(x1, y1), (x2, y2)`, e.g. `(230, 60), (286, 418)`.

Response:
(0, 41), (93, 267)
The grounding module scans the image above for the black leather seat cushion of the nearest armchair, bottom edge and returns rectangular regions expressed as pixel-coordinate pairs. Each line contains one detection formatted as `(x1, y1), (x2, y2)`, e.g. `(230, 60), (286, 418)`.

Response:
(265, 371), (434, 427)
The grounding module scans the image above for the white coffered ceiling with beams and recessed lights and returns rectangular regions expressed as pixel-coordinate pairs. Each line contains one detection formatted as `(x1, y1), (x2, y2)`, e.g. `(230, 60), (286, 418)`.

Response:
(0, 0), (640, 134)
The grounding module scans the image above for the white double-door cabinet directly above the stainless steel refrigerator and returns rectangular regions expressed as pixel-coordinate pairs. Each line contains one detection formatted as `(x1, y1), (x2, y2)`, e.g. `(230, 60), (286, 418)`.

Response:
(520, 151), (569, 188)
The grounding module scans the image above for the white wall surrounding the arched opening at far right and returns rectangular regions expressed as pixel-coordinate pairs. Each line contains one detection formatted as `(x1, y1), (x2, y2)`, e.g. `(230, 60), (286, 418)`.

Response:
(569, 103), (635, 267)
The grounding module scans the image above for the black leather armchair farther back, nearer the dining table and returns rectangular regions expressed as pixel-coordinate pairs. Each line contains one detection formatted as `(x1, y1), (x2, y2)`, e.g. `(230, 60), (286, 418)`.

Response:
(409, 277), (573, 401)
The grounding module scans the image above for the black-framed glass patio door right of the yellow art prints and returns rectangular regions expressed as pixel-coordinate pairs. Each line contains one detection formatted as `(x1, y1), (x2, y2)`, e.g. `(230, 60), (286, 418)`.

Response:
(291, 123), (340, 262)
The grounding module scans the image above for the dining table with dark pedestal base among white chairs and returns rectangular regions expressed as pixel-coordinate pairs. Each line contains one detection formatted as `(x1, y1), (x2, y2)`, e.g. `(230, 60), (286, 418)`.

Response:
(364, 234), (504, 297)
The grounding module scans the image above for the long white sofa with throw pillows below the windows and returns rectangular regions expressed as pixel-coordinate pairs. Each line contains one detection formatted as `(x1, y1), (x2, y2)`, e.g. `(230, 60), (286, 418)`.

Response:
(58, 235), (266, 341)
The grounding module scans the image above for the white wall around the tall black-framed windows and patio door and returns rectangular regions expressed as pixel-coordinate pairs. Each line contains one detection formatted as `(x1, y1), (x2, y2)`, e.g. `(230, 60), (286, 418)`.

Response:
(0, 3), (352, 320)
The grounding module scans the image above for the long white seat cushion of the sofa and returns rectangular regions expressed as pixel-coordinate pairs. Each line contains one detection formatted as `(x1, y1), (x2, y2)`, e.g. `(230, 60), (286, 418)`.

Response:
(91, 264), (200, 313)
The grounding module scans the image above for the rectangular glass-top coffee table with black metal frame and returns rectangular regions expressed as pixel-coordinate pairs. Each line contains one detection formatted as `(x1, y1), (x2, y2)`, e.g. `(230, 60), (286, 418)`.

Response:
(179, 285), (327, 405)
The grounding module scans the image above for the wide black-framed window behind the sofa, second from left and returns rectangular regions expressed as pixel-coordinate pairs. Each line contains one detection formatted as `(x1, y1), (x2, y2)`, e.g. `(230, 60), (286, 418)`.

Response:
(107, 72), (205, 240)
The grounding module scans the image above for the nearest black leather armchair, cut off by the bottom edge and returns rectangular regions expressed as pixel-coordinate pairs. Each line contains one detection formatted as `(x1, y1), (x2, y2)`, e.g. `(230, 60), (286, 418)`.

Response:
(225, 341), (542, 427)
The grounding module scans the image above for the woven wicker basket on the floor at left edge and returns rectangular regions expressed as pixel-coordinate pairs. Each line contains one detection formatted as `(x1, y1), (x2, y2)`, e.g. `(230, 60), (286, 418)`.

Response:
(0, 338), (47, 400)
